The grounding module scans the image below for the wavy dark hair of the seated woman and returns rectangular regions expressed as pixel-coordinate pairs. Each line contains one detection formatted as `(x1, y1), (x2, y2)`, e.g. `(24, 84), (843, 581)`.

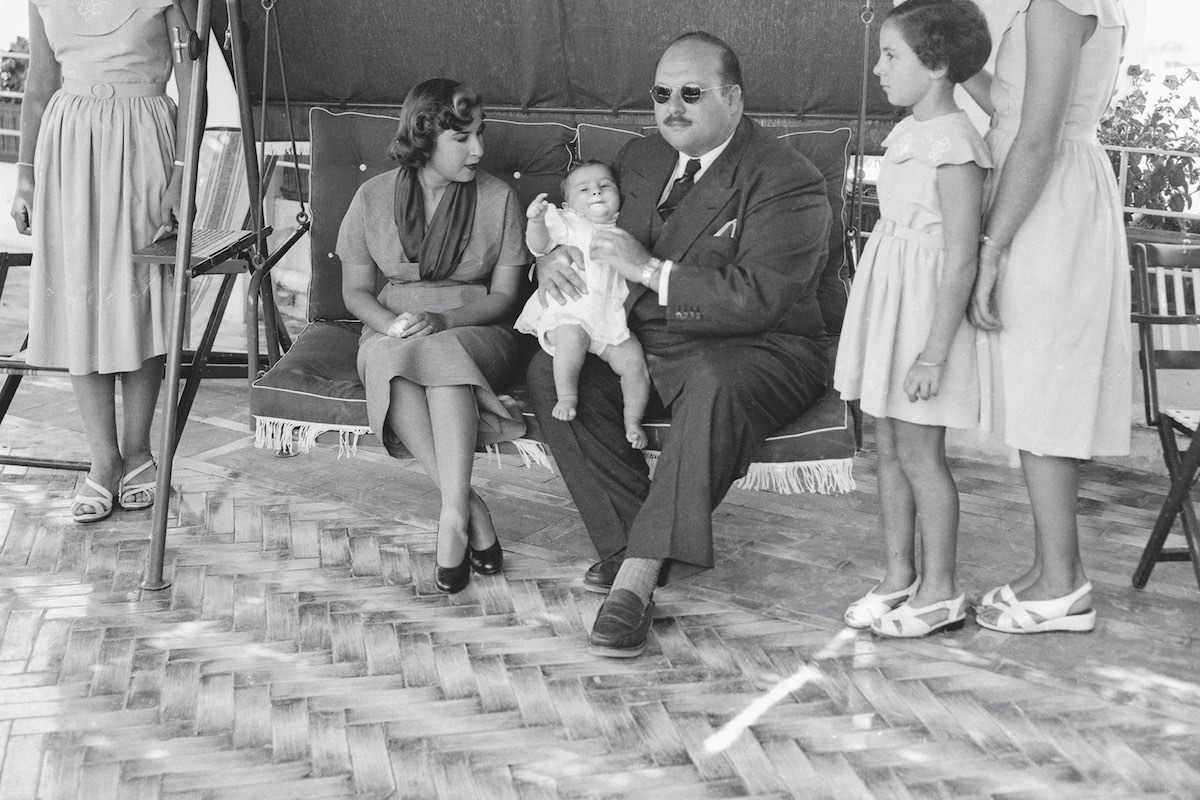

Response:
(388, 78), (484, 169)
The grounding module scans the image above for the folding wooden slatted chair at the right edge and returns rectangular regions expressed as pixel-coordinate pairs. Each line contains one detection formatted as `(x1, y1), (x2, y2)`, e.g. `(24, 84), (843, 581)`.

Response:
(1132, 241), (1200, 589)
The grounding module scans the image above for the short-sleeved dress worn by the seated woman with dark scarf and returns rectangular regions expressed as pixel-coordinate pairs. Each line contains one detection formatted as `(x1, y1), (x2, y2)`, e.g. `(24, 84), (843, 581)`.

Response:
(337, 170), (530, 453)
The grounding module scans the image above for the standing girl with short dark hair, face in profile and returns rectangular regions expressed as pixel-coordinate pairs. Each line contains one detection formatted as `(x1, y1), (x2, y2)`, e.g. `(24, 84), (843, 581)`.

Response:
(834, 0), (991, 637)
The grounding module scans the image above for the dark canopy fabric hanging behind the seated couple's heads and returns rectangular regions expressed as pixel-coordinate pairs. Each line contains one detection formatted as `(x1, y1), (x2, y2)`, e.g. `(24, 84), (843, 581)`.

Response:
(212, 0), (894, 118)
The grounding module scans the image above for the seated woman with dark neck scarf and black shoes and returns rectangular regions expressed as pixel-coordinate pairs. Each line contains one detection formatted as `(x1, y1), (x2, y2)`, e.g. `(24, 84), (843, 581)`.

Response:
(337, 78), (530, 593)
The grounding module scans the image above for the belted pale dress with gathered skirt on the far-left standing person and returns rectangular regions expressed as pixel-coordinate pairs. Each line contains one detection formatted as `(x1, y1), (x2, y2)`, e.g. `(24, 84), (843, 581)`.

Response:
(26, 0), (175, 375)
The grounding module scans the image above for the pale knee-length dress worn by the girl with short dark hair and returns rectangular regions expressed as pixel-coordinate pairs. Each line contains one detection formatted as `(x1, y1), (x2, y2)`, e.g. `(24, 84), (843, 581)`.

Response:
(834, 112), (991, 428)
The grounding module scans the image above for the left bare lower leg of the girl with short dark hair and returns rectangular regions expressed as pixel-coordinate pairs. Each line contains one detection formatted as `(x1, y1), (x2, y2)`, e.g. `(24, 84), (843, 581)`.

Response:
(874, 417), (917, 595)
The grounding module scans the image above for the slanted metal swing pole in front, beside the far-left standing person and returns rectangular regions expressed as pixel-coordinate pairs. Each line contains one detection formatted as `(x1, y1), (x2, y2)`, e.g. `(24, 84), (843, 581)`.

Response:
(142, 0), (211, 590)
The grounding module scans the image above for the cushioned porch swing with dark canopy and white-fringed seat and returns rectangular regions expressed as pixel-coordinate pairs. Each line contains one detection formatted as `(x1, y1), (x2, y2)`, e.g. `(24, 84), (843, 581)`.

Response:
(136, 0), (895, 585)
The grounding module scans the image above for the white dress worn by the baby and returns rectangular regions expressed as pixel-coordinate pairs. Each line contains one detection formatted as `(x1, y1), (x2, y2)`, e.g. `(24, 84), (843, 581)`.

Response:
(516, 206), (630, 355)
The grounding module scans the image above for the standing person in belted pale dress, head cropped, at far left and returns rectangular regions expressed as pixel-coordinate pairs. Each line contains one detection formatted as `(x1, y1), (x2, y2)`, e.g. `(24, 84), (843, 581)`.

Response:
(12, 0), (196, 522)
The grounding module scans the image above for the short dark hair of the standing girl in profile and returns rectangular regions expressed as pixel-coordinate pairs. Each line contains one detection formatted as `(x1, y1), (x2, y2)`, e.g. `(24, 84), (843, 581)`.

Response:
(886, 0), (991, 83)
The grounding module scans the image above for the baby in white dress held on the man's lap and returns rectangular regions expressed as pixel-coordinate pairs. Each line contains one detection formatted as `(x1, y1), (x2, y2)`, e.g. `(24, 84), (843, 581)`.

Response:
(516, 161), (650, 449)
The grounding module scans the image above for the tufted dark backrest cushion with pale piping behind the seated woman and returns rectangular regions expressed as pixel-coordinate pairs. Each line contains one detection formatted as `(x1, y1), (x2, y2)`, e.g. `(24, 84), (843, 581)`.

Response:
(308, 108), (575, 321)
